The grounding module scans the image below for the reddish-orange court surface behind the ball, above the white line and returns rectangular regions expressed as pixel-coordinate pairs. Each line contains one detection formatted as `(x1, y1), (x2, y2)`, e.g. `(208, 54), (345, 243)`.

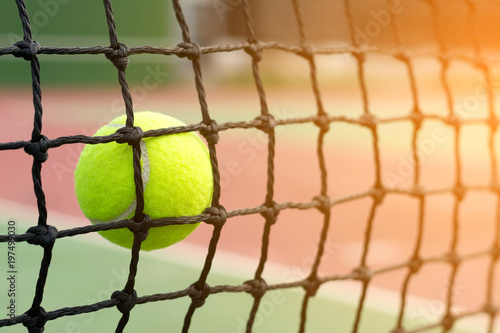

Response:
(0, 83), (500, 330)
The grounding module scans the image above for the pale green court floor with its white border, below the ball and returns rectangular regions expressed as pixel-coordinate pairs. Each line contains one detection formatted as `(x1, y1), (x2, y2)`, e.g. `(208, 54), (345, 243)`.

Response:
(0, 202), (484, 333)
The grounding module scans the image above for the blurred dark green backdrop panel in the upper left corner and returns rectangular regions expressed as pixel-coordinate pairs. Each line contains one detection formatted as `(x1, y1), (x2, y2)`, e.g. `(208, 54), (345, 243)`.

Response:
(0, 0), (173, 86)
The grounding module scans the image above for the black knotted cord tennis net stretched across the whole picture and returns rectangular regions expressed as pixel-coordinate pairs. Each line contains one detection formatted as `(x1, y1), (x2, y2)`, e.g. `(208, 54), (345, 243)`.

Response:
(0, 0), (500, 333)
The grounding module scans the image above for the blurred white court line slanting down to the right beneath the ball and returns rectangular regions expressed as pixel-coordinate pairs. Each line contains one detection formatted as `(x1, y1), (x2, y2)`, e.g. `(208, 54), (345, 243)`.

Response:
(0, 199), (494, 333)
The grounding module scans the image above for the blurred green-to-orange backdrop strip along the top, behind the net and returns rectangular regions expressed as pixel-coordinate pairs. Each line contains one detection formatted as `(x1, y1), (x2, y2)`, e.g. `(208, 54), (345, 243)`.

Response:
(0, 0), (500, 86)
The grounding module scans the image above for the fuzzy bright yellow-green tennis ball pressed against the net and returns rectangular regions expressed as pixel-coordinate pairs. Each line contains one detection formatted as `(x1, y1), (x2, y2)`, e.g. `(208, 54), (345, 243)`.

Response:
(75, 112), (213, 251)
